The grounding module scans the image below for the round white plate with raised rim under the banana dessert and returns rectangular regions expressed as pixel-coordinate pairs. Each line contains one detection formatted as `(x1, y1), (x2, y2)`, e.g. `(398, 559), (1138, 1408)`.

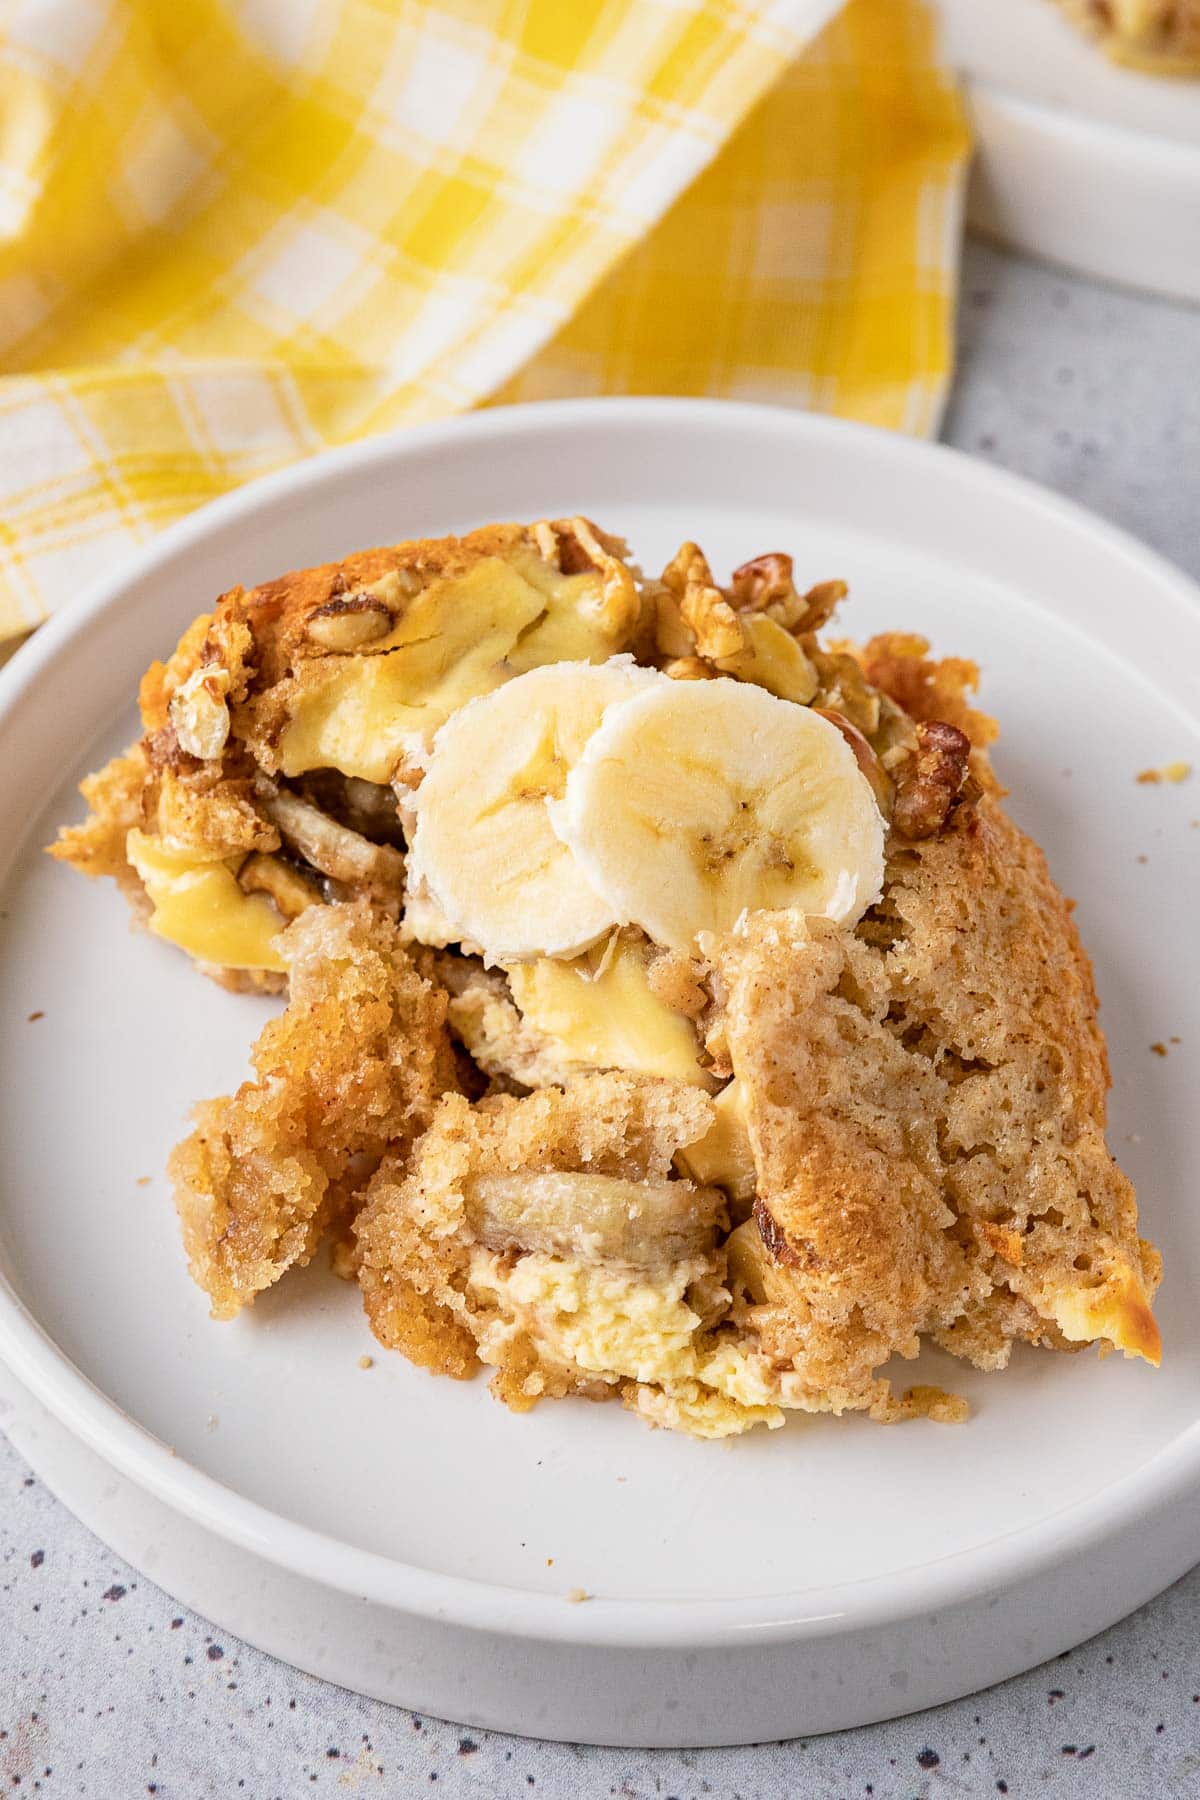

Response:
(0, 400), (1200, 1744)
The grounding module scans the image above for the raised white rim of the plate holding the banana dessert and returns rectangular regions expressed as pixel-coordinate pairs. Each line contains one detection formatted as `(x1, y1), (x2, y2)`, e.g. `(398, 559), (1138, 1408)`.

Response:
(0, 396), (1200, 1649)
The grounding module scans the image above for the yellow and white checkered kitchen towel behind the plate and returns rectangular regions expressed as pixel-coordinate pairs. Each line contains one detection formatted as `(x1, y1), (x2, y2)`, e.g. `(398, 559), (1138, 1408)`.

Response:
(0, 0), (966, 639)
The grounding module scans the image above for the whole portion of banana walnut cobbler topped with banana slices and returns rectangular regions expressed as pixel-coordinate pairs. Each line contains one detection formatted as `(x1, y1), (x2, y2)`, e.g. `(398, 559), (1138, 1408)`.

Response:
(54, 518), (1159, 1436)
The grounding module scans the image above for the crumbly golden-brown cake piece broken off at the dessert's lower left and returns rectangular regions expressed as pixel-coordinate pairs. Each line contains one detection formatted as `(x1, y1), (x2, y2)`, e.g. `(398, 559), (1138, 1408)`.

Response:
(169, 902), (455, 1319)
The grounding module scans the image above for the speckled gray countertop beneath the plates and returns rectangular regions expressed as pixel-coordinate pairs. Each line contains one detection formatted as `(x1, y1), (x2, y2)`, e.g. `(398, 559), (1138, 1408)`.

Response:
(0, 245), (1200, 1800)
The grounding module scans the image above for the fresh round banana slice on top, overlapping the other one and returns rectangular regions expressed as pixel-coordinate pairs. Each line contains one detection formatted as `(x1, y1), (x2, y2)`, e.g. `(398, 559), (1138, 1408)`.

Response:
(549, 679), (883, 952)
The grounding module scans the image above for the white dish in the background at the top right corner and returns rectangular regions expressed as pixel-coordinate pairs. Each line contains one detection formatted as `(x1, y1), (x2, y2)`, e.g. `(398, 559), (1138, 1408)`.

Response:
(939, 0), (1200, 301)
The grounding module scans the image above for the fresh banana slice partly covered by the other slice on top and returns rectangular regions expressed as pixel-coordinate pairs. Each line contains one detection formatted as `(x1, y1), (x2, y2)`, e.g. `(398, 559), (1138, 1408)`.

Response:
(407, 657), (673, 963)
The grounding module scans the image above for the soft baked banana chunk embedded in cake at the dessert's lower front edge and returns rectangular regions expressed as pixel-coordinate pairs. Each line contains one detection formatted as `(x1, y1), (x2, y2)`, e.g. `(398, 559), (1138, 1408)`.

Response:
(466, 1170), (725, 1269)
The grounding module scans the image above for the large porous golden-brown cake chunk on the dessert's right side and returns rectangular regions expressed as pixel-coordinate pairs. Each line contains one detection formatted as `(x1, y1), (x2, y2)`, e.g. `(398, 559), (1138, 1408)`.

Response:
(721, 799), (1159, 1404)
